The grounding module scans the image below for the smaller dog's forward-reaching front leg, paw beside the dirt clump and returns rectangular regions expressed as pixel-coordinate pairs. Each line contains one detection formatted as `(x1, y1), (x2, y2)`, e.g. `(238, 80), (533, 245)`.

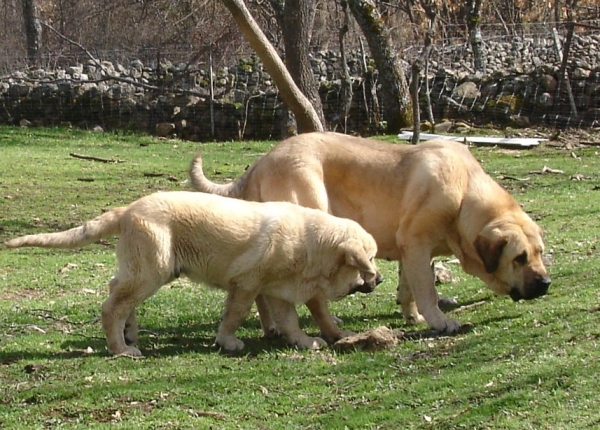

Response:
(268, 297), (327, 349)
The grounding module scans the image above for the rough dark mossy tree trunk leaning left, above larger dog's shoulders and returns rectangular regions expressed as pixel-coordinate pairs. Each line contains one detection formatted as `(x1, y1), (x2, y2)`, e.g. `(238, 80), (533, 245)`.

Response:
(348, 0), (412, 134)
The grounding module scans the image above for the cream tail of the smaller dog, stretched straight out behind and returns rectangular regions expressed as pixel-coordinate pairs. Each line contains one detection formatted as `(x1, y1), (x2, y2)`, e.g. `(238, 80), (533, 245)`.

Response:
(5, 207), (127, 248)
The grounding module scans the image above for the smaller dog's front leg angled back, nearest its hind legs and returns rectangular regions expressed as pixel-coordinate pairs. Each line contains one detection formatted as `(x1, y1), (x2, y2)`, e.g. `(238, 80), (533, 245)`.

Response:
(215, 287), (256, 352)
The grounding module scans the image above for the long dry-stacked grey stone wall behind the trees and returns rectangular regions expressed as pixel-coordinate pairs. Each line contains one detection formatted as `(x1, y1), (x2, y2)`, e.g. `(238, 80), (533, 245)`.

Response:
(0, 31), (600, 141)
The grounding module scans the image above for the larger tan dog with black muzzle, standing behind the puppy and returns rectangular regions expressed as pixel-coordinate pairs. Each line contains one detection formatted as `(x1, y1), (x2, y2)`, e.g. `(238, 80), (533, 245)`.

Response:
(190, 133), (550, 332)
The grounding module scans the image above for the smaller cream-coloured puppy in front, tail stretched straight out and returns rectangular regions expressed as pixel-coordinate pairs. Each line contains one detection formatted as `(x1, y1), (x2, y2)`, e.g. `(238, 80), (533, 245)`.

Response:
(6, 191), (381, 355)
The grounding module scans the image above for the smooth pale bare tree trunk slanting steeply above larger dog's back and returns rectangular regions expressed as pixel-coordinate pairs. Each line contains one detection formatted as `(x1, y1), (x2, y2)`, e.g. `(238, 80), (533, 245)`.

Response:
(221, 0), (323, 132)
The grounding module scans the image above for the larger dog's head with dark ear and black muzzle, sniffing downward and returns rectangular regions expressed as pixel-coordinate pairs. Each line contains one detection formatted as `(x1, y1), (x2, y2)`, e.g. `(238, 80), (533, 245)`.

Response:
(473, 213), (551, 301)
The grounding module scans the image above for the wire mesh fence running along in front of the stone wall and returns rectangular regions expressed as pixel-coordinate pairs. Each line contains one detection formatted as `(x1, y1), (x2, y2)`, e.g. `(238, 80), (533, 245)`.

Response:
(0, 21), (600, 140)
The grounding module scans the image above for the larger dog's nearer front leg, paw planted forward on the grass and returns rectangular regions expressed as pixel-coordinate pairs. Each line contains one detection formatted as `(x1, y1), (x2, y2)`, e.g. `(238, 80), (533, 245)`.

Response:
(402, 252), (460, 333)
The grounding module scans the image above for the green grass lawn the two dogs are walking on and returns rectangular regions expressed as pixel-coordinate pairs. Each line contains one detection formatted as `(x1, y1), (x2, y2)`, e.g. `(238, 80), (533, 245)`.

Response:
(0, 128), (600, 430)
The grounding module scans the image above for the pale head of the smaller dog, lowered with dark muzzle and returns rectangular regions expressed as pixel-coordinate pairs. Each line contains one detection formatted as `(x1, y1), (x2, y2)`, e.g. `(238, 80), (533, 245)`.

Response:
(332, 228), (383, 300)
